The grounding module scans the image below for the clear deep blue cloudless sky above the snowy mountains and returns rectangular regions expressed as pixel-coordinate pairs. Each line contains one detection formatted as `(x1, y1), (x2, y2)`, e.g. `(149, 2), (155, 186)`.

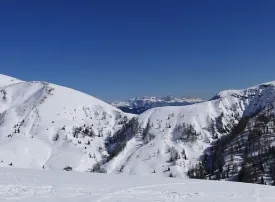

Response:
(0, 0), (275, 100)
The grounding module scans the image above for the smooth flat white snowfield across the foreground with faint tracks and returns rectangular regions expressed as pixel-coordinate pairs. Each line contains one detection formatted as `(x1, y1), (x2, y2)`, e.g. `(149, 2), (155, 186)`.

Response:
(0, 168), (275, 202)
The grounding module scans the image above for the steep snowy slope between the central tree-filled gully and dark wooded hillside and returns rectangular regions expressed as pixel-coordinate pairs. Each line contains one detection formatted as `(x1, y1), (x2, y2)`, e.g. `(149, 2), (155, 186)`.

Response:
(107, 82), (275, 177)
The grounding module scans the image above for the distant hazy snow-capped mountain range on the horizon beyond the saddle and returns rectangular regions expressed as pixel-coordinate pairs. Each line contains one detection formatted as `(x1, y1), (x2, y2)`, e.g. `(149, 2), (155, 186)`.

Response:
(110, 96), (203, 114)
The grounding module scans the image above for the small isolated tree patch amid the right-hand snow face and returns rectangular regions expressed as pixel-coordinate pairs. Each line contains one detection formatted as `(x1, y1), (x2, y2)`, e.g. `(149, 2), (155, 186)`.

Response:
(173, 123), (200, 143)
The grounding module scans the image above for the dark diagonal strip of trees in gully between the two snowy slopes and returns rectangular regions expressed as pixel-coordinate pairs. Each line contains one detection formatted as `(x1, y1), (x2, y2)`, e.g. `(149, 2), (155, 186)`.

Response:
(105, 117), (140, 161)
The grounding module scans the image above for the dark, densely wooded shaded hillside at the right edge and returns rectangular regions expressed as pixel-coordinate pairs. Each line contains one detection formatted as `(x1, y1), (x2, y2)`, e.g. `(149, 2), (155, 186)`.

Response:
(190, 109), (275, 185)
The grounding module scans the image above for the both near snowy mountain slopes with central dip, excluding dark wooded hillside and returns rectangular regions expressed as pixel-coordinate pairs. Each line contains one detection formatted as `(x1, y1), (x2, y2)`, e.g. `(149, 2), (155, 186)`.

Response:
(0, 75), (275, 184)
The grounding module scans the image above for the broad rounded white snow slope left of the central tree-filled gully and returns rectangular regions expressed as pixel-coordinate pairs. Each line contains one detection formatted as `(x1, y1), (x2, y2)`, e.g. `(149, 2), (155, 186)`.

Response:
(0, 77), (133, 171)
